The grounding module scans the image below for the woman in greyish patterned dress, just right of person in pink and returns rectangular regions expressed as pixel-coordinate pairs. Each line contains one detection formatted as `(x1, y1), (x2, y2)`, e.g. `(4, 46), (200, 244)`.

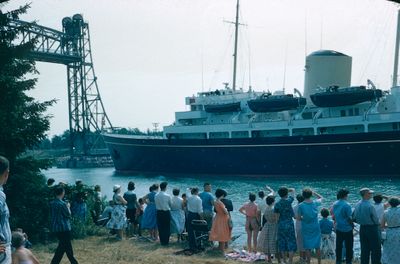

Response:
(258, 195), (280, 263)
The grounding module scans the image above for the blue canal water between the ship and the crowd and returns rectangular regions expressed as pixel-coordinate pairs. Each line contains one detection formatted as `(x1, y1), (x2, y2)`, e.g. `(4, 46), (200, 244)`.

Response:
(44, 168), (400, 253)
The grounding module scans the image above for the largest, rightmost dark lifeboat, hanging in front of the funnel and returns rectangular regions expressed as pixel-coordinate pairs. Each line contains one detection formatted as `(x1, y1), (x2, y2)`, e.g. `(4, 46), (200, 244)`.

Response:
(310, 86), (383, 107)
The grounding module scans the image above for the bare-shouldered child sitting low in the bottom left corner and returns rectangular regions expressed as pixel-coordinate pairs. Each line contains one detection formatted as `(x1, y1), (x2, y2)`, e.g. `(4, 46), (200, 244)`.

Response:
(11, 232), (39, 264)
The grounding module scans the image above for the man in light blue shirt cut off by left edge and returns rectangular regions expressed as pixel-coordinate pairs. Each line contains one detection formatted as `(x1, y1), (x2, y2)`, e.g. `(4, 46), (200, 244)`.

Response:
(0, 156), (11, 264)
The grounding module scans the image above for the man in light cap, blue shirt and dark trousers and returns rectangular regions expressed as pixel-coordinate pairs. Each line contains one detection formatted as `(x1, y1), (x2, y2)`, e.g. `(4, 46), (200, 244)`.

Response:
(353, 188), (381, 264)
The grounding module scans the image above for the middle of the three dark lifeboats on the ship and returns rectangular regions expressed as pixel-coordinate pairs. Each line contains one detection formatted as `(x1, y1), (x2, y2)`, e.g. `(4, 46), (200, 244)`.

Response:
(247, 93), (307, 113)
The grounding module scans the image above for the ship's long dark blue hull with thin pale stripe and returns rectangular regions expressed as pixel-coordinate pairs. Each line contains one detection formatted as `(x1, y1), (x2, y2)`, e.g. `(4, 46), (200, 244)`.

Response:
(104, 131), (400, 177)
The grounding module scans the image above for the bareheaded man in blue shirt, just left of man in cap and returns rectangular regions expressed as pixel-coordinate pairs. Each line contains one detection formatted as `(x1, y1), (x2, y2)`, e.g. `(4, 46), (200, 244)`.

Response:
(332, 189), (354, 264)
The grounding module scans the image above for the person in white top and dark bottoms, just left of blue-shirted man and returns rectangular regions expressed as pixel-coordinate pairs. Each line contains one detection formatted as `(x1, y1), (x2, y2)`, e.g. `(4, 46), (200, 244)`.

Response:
(187, 188), (203, 250)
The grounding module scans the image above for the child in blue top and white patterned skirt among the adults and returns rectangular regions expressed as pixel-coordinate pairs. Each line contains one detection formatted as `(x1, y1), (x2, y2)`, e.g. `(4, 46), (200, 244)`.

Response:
(319, 208), (336, 259)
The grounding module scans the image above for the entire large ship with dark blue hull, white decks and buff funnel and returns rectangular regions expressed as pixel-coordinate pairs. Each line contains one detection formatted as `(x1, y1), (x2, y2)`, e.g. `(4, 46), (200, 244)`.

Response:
(103, 0), (400, 178)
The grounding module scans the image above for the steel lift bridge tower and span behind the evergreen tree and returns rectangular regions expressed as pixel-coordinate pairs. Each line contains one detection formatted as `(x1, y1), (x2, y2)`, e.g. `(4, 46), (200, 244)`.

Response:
(10, 14), (112, 157)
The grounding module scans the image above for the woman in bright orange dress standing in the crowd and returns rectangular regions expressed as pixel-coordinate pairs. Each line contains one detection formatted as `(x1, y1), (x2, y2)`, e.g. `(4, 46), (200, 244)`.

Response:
(210, 189), (231, 251)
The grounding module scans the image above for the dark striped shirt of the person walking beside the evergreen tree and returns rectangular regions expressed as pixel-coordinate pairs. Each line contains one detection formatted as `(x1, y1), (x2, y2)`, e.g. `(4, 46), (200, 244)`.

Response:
(50, 198), (71, 232)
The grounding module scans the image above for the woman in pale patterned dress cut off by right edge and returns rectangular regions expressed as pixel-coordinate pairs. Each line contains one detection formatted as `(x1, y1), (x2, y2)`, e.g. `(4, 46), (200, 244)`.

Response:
(381, 197), (400, 264)
